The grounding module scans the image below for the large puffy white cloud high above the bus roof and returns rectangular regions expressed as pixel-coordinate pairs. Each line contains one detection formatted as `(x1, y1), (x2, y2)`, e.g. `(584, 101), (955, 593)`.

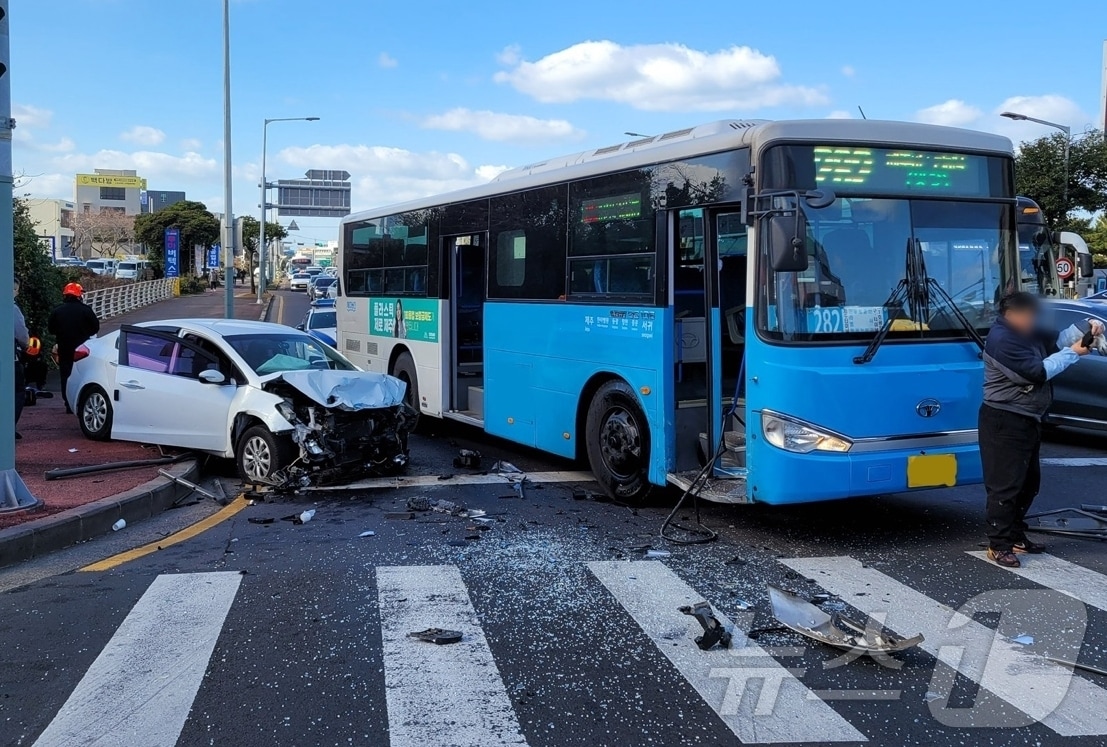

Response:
(495, 41), (826, 111)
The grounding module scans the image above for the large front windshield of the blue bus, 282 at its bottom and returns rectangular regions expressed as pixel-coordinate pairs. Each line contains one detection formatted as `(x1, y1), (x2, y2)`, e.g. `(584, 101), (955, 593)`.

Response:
(758, 197), (1014, 342)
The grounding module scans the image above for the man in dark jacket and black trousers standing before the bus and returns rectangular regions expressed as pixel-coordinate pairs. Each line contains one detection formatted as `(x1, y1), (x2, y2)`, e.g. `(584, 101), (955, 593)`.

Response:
(979, 292), (1104, 568)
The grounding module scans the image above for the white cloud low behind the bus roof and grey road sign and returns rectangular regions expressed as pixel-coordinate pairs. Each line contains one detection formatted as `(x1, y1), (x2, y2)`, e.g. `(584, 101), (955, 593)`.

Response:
(277, 144), (507, 210)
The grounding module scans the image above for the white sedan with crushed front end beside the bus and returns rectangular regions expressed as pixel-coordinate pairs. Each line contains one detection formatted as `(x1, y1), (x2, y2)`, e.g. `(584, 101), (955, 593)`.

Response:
(66, 319), (414, 487)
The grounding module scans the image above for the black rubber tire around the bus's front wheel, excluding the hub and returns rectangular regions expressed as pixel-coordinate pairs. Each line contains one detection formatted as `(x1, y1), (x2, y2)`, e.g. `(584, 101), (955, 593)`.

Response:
(584, 381), (653, 502)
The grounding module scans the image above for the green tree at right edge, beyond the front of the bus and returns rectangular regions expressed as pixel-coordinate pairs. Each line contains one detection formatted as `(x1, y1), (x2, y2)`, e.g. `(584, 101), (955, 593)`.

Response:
(1015, 131), (1107, 231)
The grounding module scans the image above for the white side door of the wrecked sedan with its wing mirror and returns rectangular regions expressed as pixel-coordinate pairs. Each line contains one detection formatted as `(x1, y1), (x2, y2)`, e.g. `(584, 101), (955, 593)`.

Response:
(112, 326), (237, 453)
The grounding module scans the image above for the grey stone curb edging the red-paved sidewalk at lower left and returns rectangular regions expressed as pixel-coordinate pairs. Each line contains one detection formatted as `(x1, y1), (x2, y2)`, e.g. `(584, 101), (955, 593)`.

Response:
(0, 459), (199, 568)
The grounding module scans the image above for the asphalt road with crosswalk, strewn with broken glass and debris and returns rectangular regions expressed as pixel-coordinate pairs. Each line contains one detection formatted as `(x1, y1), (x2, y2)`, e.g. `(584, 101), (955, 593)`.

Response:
(0, 294), (1107, 747)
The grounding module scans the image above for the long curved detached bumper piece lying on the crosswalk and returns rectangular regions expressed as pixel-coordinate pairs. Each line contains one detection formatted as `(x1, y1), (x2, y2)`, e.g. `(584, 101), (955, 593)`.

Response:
(768, 587), (922, 656)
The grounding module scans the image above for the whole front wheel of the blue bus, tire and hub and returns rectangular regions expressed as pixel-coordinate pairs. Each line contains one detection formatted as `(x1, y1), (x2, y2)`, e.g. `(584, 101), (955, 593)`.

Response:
(584, 381), (651, 501)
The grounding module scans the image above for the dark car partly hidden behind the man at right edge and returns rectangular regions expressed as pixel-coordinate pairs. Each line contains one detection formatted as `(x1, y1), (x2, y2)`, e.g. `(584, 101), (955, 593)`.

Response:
(1046, 301), (1107, 430)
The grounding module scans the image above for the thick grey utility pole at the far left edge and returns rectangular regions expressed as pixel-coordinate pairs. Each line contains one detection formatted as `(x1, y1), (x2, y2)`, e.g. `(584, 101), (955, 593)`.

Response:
(0, 0), (42, 513)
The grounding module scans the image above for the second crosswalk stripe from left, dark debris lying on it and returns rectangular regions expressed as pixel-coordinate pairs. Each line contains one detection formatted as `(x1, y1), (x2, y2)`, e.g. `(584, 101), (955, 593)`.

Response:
(376, 566), (527, 747)
